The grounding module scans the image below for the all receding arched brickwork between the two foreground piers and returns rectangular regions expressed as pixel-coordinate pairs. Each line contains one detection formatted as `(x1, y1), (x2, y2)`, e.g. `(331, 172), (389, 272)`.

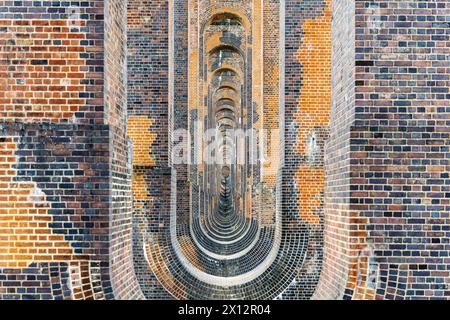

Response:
(128, 0), (331, 299)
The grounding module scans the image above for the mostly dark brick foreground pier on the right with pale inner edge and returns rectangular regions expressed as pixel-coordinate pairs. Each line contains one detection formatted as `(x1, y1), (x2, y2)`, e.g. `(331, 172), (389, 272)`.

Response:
(314, 1), (450, 299)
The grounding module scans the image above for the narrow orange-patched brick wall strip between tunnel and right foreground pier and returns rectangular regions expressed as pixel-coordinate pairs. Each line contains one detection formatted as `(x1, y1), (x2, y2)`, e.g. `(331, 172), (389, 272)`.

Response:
(282, 1), (331, 299)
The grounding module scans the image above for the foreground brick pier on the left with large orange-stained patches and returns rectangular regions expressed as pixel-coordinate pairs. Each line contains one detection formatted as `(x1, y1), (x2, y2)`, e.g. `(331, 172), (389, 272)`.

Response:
(0, 1), (139, 299)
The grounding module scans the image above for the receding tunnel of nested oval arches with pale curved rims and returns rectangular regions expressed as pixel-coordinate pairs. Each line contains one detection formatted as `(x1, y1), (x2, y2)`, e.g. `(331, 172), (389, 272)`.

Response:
(128, 1), (330, 300)
